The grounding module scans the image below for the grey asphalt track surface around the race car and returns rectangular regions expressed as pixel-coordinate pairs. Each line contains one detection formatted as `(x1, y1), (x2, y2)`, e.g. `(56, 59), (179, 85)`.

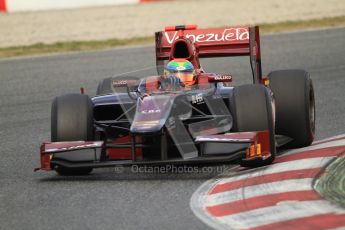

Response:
(0, 28), (345, 230)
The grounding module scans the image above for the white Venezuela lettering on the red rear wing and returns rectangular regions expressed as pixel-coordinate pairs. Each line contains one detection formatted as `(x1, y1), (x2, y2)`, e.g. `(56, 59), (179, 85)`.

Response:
(164, 28), (249, 44)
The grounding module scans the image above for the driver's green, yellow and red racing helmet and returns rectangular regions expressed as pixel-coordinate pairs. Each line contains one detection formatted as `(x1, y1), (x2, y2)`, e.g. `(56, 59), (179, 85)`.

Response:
(164, 58), (196, 86)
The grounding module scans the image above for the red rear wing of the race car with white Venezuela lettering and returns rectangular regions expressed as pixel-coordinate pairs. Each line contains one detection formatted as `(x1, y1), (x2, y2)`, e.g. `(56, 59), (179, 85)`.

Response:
(155, 25), (262, 83)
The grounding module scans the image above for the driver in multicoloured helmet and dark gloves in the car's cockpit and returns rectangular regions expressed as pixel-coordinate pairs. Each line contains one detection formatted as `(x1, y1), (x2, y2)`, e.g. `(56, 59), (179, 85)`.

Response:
(160, 59), (196, 90)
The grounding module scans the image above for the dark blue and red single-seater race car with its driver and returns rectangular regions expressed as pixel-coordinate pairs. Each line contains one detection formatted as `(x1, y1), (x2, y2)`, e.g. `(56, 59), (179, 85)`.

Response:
(36, 25), (315, 175)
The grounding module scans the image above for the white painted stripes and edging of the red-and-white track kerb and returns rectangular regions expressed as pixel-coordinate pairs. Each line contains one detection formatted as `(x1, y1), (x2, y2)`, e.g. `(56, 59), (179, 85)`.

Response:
(190, 135), (345, 230)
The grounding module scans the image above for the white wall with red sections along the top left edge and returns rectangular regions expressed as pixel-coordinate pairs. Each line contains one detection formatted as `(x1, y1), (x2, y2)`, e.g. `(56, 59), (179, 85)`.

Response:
(0, 0), (159, 12)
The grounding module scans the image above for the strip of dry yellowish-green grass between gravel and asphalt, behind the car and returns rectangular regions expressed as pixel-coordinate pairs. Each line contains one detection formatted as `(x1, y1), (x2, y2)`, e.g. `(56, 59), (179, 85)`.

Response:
(0, 16), (345, 58)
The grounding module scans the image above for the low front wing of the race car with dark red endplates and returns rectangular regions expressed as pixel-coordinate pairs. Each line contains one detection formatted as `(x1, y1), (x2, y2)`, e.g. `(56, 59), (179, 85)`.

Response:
(35, 131), (271, 171)
